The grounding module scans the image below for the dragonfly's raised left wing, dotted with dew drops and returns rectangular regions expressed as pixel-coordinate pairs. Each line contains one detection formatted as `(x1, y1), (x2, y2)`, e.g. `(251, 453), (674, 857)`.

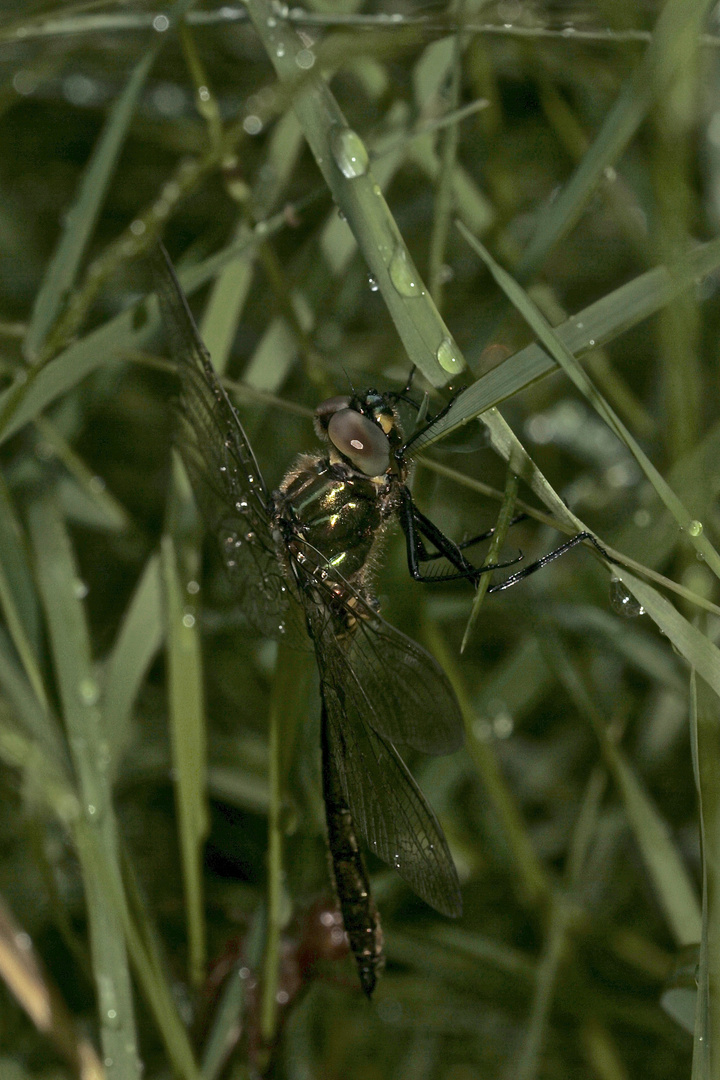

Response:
(154, 247), (289, 637)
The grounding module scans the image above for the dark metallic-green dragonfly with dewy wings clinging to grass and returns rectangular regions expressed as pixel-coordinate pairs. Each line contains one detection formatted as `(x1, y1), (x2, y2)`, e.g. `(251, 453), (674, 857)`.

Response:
(154, 248), (604, 998)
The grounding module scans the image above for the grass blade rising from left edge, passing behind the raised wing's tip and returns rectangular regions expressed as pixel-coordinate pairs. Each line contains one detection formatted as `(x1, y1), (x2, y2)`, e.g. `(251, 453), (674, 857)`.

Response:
(0, 198), (306, 443)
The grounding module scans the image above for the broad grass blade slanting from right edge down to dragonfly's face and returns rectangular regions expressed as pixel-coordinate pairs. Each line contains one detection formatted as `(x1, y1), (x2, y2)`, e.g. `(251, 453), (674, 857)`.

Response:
(421, 240), (720, 446)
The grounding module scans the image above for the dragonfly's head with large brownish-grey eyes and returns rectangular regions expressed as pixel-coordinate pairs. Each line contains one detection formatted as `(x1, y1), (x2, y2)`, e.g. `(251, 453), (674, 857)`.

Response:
(315, 390), (403, 476)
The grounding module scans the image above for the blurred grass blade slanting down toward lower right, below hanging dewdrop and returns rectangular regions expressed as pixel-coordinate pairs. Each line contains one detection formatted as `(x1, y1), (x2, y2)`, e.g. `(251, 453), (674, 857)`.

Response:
(543, 623), (701, 945)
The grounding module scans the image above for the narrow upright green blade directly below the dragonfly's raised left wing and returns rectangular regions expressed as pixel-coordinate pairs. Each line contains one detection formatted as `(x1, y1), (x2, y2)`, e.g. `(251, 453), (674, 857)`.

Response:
(161, 522), (208, 987)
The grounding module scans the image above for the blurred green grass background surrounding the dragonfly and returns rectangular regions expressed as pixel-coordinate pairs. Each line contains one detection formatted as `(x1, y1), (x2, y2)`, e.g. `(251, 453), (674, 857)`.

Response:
(0, 0), (720, 1080)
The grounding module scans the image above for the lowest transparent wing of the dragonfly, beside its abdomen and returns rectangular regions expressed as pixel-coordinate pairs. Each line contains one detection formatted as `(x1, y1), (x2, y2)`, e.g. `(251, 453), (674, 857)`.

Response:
(321, 673), (462, 916)
